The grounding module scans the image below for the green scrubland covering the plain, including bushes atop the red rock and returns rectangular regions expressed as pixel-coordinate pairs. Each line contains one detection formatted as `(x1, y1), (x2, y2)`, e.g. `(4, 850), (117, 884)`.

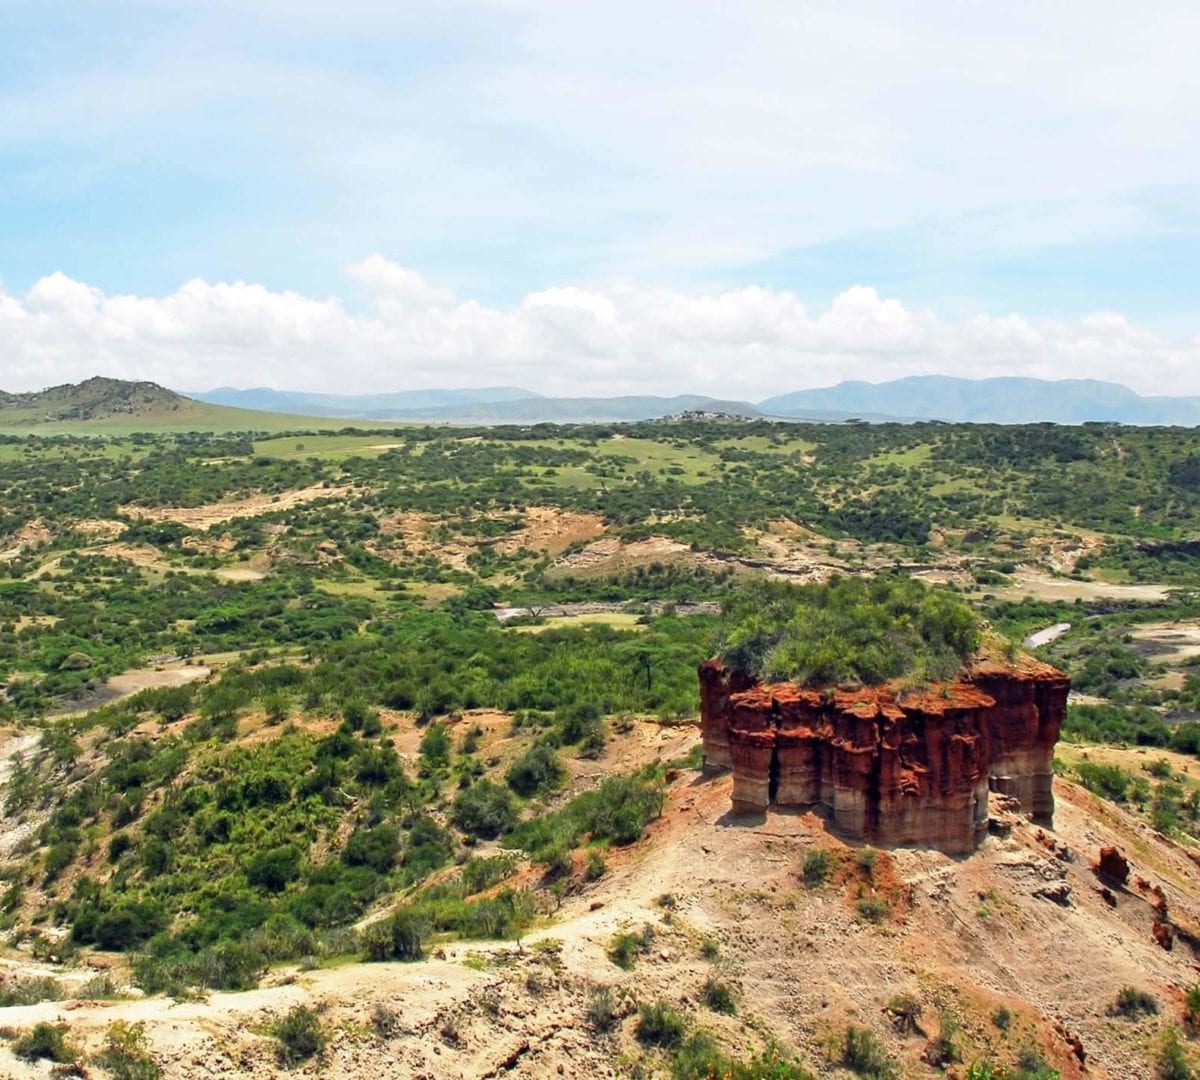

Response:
(0, 422), (1200, 1080)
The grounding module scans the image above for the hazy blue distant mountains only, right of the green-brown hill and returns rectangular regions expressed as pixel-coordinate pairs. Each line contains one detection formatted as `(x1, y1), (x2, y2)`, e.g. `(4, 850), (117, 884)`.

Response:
(190, 376), (1200, 426)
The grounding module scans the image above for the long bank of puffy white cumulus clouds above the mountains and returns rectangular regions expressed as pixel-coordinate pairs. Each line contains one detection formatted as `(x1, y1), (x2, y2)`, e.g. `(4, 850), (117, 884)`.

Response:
(0, 254), (1200, 401)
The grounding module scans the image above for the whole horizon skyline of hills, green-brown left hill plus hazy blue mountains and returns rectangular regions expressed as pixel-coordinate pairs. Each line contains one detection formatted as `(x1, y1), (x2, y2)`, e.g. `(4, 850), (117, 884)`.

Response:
(0, 376), (1200, 431)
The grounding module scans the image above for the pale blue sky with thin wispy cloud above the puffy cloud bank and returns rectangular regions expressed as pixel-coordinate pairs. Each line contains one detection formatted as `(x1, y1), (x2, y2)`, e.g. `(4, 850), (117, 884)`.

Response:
(0, 0), (1200, 391)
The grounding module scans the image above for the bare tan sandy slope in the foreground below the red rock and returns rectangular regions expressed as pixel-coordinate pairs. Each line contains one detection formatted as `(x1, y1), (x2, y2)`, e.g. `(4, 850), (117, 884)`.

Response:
(0, 734), (1200, 1080)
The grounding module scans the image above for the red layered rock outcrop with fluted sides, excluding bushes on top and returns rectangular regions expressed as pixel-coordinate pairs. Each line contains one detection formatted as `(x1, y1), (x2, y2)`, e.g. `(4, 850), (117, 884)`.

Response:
(700, 658), (1070, 854)
